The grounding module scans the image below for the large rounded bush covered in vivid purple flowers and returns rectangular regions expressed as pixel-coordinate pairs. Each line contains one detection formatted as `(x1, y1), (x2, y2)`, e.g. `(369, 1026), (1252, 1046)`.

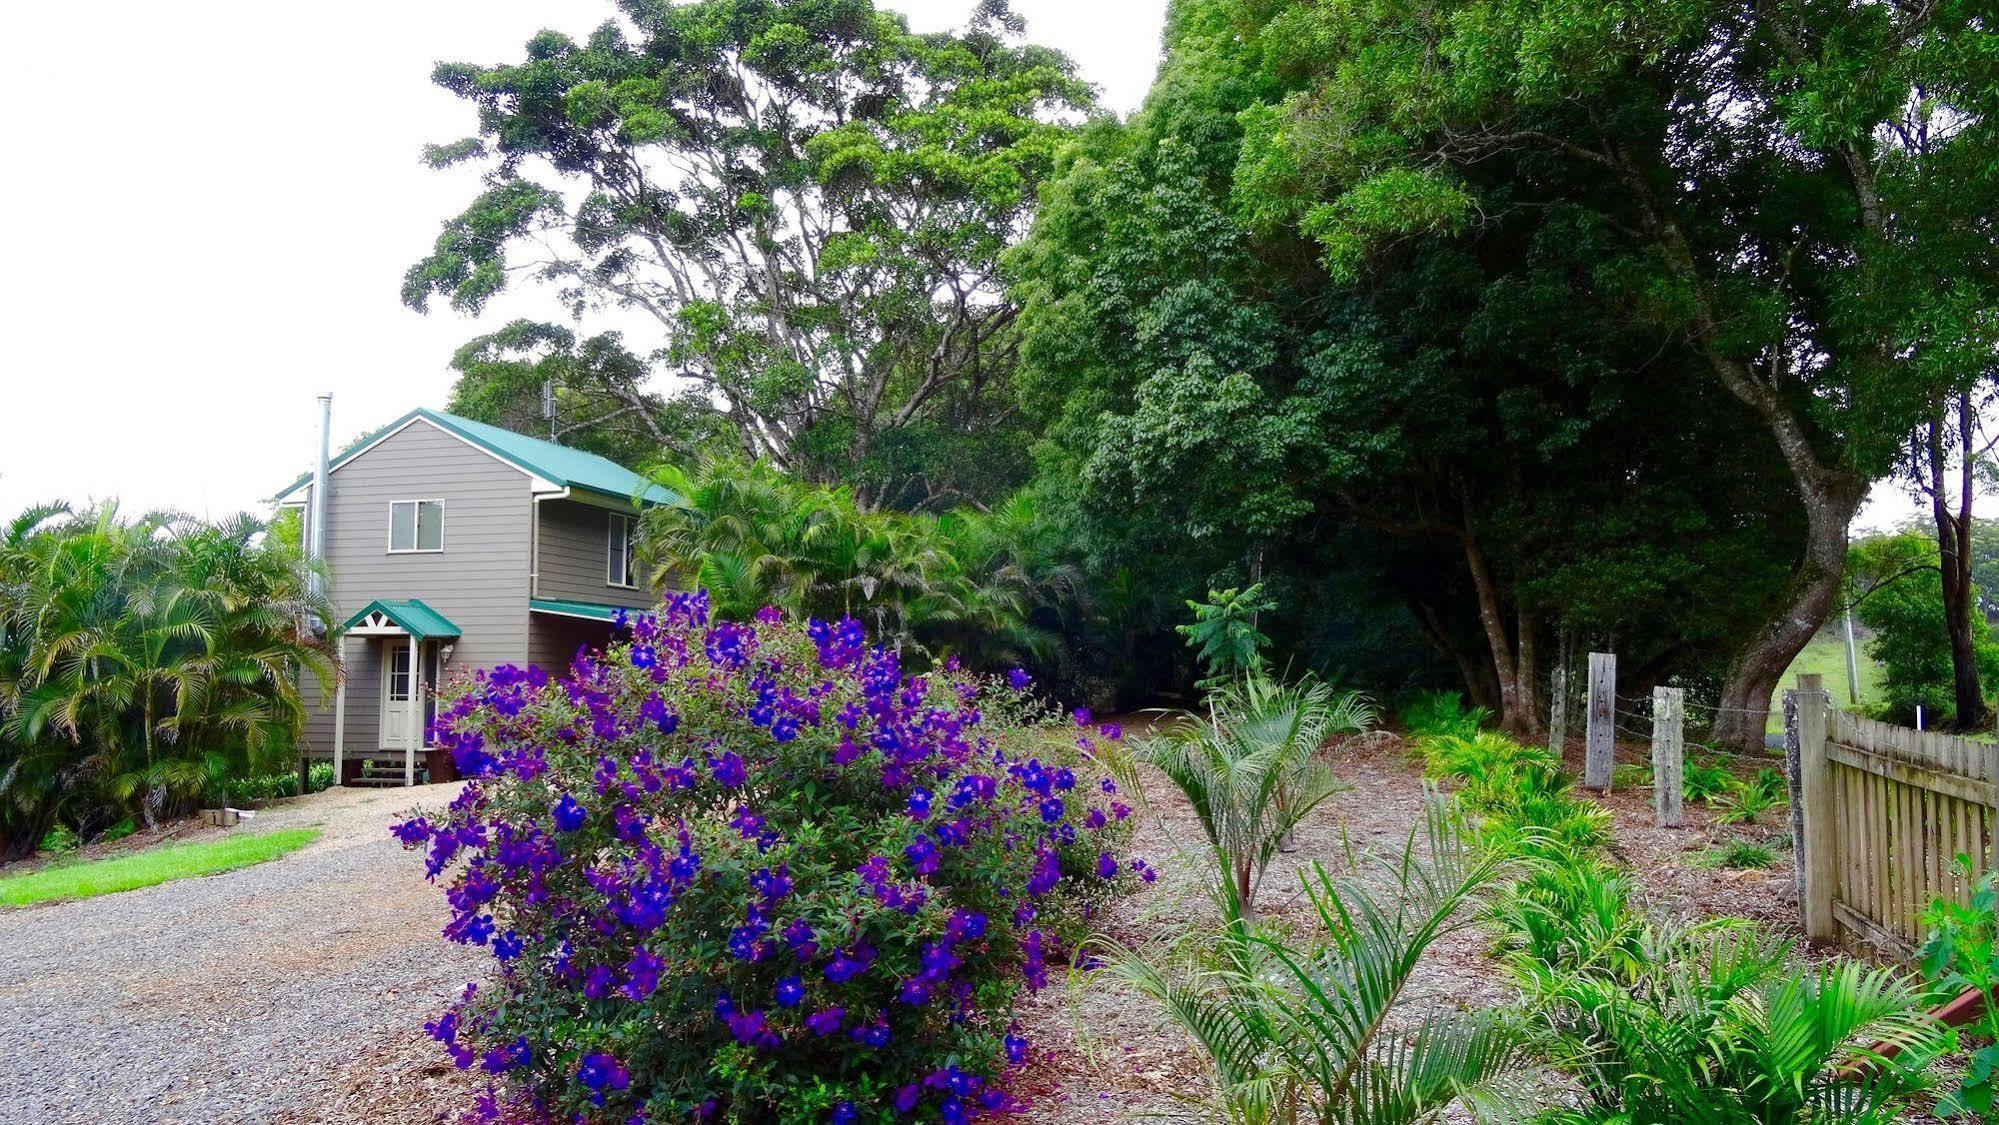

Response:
(396, 593), (1149, 1123)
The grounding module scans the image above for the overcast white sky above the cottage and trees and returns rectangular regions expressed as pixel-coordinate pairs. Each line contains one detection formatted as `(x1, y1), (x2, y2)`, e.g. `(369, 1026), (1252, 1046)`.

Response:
(0, 0), (1909, 535)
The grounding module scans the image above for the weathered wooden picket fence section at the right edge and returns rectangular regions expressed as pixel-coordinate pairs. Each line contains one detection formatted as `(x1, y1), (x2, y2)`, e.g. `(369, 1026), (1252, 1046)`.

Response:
(1793, 675), (1999, 955)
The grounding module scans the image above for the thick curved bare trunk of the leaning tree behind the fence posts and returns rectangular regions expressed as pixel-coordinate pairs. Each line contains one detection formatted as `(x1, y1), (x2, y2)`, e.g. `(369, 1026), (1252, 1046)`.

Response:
(1713, 474), (1867, 753)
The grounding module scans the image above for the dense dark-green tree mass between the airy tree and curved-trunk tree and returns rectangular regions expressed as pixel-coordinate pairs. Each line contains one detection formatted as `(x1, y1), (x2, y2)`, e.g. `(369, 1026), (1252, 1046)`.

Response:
(1011, 0), (1801, 725)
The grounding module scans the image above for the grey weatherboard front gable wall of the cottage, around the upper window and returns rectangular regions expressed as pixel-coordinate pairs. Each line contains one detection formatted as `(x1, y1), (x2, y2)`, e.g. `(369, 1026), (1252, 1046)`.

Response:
(306, 420), (531, 757)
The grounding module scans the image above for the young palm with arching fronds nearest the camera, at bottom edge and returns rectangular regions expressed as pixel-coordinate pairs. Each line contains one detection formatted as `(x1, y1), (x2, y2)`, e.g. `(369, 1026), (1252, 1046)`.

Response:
(1103, 795), (1525, 1125)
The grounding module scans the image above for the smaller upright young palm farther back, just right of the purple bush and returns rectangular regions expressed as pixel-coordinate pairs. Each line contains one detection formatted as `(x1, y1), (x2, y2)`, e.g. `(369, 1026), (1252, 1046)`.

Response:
(1137, 677), (1373, 915)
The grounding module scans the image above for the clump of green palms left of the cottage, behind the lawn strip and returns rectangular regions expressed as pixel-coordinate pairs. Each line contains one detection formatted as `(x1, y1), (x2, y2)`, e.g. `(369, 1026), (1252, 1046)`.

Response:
(0, 506), (336, 855)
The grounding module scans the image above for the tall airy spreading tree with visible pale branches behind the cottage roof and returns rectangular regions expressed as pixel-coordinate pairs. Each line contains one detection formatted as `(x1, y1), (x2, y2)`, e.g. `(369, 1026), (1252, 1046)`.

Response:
(404, 0), (1091, 504)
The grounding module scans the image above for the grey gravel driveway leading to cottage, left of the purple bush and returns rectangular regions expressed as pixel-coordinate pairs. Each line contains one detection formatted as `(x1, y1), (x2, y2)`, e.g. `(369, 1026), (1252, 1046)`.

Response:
(0, 785), (488, 1123)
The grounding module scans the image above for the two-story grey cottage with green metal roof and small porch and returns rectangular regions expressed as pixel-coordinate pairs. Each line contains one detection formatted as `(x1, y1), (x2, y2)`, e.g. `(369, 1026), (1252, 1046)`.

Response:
(276, 410), (670, 783)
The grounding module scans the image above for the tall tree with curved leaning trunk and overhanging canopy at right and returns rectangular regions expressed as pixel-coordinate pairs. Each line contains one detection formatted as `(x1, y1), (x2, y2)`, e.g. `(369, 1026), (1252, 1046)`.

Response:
(1239, 0), (1999, 745)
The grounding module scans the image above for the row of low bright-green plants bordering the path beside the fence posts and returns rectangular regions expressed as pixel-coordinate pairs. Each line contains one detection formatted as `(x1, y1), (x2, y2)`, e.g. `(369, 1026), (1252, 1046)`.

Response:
(1423, 735), (1949, 1125)
